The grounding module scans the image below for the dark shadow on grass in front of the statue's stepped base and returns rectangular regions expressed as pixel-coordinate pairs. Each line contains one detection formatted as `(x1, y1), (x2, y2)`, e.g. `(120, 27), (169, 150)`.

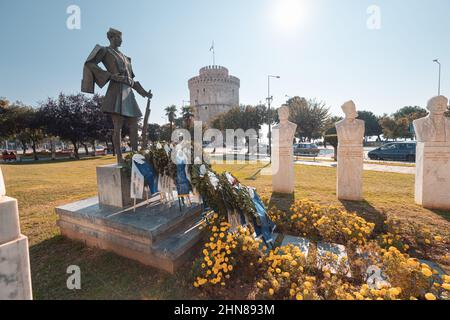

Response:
(30, 236), (198, 300)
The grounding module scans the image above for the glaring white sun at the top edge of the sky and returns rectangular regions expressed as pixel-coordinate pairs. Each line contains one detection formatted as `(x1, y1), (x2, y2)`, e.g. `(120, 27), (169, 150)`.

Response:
(271, 0), (305, 32)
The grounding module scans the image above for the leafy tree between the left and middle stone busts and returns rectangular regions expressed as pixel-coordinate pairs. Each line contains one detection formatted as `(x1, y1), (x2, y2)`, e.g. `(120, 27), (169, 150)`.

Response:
(287, 97), (330, 141)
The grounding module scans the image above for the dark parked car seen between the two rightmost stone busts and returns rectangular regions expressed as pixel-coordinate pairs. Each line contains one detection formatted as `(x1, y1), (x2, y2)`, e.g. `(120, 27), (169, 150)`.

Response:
(368, 142), (416, 162)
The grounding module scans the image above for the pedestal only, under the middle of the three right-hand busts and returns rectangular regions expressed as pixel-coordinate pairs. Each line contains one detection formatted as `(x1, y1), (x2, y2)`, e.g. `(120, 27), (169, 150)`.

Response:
(336, 145), (364, 201)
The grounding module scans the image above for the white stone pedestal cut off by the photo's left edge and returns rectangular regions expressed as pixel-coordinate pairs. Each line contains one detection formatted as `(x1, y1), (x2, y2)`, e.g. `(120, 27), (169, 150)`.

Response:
(0, 169), (33, 300)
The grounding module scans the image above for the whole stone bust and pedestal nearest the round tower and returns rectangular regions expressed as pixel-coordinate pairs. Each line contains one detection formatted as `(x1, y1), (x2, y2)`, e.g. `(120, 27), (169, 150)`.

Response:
(272, 106), (297, 194)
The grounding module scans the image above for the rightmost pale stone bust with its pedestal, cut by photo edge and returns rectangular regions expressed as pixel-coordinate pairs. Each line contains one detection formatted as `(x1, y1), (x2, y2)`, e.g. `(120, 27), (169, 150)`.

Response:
(414, 96), (450, 210)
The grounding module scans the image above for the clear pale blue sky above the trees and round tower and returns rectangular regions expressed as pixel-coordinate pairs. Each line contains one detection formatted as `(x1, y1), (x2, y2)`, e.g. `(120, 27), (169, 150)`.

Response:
(0, 0), (450, 123)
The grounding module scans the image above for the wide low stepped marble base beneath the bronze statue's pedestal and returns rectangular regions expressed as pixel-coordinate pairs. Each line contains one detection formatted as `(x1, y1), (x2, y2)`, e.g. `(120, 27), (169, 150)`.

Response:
(56, 198), (207, 273)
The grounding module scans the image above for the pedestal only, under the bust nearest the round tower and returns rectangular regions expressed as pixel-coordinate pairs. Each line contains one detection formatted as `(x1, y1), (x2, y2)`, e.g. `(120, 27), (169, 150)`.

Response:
(272, 147), (295, 194)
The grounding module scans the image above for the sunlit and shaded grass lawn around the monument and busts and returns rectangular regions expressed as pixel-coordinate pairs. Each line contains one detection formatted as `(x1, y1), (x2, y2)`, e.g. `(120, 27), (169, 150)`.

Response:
(1, 157), (450, 299)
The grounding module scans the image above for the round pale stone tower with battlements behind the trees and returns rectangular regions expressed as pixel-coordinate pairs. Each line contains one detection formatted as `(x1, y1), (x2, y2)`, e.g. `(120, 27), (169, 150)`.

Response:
(188, 66), (240, 124)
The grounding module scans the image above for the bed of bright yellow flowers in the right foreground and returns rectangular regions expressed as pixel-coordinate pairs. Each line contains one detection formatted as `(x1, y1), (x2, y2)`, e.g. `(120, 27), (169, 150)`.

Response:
(193, 201), (450, 300)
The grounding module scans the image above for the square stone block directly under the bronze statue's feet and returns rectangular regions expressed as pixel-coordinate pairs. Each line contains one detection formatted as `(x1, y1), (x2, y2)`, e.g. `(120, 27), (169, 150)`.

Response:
(97, 164), (131, 208)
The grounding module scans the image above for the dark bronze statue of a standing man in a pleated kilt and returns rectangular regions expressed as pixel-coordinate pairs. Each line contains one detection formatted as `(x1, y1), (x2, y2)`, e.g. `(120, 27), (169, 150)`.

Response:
(81, 28), (152, 163)
